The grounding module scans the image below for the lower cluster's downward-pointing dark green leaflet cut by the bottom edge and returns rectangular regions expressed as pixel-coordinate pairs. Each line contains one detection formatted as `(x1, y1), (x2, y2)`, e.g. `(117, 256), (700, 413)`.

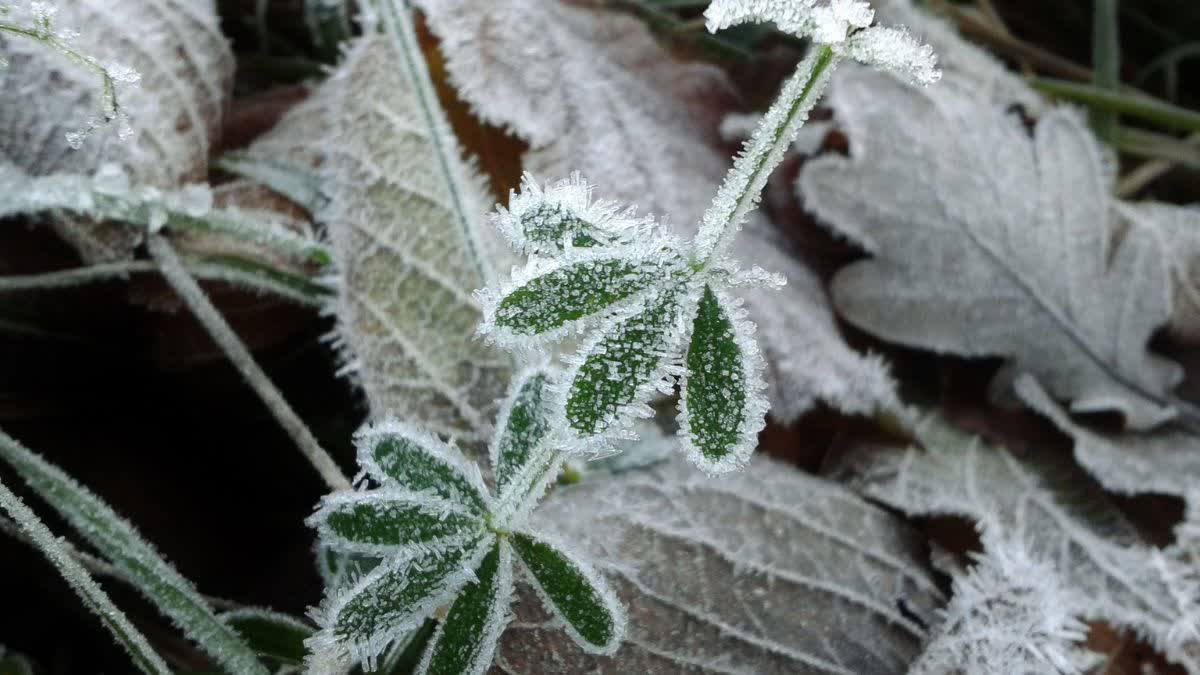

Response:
(418, 542), (512, 675)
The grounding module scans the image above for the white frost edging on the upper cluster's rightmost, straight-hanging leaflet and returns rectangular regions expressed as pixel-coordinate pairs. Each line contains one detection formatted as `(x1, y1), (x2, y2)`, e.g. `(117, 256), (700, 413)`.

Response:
(677, 283), (768, 476)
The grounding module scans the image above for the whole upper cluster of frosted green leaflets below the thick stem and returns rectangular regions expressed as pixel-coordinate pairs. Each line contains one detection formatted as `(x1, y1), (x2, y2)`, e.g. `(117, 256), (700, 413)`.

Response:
(479, 177), (775, 473)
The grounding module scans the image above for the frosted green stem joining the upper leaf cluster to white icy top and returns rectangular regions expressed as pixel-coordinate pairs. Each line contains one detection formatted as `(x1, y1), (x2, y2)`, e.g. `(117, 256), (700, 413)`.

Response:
(694, 43), (840, 269)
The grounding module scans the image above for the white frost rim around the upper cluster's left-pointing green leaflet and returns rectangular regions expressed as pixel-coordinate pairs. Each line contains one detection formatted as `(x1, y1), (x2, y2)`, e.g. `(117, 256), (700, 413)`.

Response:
(475, 234), (682, 351)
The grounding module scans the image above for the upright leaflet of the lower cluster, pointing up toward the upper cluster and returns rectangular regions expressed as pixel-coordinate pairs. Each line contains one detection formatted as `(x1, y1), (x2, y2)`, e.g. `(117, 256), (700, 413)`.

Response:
(492, 371), (550, 498)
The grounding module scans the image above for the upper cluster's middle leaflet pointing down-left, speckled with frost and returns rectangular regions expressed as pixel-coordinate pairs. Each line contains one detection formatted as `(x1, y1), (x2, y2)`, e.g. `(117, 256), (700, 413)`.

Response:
(563, 286), (688, 437)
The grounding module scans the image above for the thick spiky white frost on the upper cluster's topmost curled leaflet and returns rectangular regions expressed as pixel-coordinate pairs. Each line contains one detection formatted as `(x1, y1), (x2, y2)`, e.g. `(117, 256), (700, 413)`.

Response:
(492, 172), (654, 255)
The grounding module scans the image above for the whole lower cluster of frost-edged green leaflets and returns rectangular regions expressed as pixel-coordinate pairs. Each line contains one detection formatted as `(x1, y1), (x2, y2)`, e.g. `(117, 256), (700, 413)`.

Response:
(306, 370), (625, 675)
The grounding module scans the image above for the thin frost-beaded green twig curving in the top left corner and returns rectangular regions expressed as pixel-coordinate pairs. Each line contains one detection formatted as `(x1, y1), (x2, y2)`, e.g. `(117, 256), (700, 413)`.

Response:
(0, 0), (142, 149)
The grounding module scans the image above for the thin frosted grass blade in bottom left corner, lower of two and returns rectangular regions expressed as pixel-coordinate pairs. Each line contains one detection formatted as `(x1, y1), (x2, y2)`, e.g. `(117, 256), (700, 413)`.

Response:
(0, 468), (170, 675)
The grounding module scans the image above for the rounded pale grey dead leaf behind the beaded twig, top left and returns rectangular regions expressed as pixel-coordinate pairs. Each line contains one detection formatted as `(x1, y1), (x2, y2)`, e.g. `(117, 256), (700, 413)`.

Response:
(0, 0), (234, 259)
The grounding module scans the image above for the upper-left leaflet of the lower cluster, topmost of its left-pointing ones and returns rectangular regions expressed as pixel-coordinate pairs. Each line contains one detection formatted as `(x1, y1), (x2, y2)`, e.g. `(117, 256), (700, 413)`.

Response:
(354, 420), (488, 513)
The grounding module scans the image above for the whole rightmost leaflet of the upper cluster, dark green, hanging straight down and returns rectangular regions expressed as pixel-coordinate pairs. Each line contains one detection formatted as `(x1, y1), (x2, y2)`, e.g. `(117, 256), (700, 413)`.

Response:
(679, 286), (767, 473)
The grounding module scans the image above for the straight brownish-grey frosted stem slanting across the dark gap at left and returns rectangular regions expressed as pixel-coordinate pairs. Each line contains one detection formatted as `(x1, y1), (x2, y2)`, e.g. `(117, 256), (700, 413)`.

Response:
(148, 234), (350, 491)
